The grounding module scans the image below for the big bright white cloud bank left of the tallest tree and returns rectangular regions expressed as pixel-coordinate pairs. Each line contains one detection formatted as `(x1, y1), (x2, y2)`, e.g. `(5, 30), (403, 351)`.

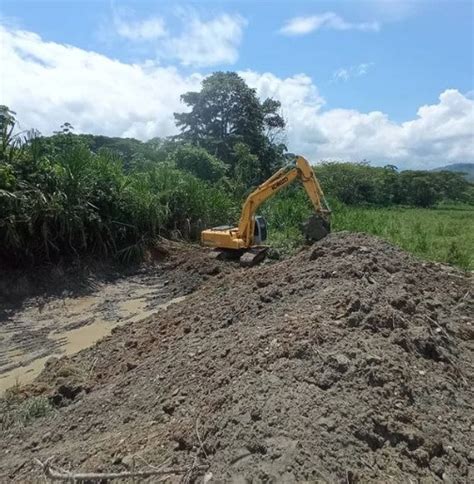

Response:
(0, 27), (201, 139)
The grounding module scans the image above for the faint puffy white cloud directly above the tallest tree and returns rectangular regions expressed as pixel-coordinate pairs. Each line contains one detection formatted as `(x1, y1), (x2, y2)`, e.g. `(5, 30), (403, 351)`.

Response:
(165, 13), (246, 67)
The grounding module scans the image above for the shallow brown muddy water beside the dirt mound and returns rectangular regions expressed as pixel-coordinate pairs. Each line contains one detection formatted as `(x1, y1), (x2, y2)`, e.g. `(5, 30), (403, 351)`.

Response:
(0, 275), (185, 394)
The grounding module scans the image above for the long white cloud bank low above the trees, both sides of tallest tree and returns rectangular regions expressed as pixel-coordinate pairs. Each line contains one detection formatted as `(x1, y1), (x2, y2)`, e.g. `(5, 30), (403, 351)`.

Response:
(0, 27), (474, 168)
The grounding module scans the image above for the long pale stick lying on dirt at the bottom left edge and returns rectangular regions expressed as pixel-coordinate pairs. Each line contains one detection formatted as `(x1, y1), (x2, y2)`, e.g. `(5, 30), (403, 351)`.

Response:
(34, 457), (209, 482)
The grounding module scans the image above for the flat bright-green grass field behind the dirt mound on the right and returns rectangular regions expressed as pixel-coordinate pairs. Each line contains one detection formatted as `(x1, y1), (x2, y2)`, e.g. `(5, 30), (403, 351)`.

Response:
(270, 205), (474, 270)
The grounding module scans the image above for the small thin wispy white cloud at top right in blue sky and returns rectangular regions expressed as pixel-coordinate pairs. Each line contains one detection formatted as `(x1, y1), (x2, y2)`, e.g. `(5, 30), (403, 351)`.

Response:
(280, 12), (380, 35)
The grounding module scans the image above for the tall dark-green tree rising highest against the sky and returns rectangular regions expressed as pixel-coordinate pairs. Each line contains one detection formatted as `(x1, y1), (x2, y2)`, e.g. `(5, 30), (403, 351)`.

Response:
(174, 72), (285, 182)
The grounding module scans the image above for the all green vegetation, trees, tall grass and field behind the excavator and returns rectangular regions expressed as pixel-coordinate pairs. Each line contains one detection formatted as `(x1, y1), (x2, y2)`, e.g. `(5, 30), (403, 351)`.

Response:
(0, 73), (474, 268)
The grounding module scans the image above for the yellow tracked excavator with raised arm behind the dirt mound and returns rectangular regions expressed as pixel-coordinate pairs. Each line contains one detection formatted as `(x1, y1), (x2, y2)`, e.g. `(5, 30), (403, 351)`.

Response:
(201, 156), (331, 267)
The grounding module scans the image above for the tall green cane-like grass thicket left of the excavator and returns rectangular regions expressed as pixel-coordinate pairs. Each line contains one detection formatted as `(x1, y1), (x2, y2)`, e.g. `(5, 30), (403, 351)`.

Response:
(0, 135), (236, 265)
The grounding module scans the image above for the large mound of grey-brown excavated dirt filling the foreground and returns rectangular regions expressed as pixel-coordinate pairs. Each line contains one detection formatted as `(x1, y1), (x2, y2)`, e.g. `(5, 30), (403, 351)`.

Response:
(0, 234), (474, 483)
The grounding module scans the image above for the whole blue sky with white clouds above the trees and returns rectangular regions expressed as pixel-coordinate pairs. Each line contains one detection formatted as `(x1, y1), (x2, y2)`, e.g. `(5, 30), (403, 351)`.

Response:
(0, 0), (474, 169)
